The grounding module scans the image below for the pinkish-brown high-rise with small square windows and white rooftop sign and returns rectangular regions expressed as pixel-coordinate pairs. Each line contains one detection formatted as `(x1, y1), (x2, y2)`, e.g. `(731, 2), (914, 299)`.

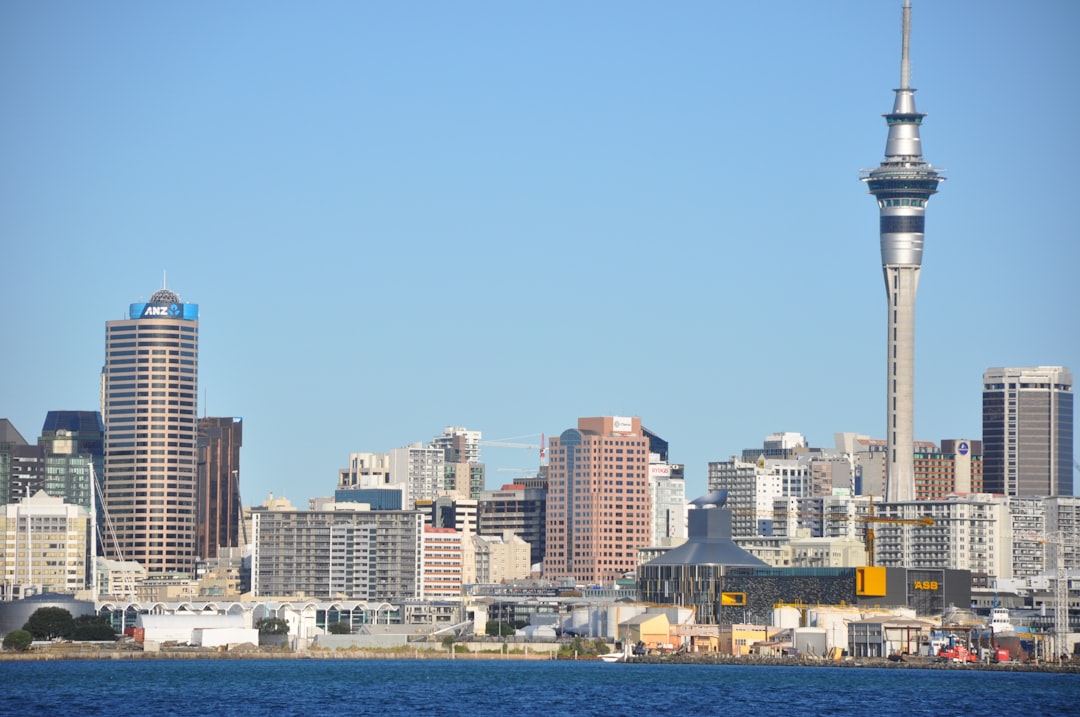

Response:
(543, 416), (651, 584)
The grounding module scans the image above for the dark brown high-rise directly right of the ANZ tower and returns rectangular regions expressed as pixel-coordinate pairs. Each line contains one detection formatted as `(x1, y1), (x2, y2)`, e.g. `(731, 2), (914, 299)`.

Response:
(195, 417), (247, 558)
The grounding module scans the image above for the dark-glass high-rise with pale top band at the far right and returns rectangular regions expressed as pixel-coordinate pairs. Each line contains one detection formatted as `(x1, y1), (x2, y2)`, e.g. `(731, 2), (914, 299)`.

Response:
(983, 366), (1072, 496)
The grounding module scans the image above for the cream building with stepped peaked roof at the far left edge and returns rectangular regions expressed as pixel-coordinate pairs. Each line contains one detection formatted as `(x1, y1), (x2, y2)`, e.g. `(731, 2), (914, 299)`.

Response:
(0, 490), (90, 600)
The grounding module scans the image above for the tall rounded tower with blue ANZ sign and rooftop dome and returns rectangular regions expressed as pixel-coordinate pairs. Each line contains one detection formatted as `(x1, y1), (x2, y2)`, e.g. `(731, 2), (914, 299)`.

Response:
(102, 289), (199, 574)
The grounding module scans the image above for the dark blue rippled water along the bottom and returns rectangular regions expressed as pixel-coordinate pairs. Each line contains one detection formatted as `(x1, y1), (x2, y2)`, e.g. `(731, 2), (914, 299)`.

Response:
(0, 660), (1080, 717)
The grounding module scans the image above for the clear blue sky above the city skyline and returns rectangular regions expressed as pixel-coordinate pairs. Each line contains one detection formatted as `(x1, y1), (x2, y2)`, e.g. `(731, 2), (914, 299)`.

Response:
(0, 0), (1080, 504)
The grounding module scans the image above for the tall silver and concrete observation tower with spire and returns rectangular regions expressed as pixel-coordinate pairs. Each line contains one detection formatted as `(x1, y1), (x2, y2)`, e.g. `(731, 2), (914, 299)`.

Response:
(861, 0), (945, 501)
